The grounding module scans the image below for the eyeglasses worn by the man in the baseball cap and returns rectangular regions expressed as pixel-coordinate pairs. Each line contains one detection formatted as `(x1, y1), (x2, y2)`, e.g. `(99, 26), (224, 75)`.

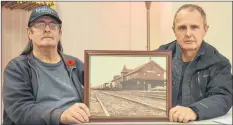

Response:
(31, 22), (60, 30)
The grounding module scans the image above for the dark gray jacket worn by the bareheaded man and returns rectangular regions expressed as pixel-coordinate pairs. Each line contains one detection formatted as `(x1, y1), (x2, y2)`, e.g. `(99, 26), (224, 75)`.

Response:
(158, 41), (232, 120)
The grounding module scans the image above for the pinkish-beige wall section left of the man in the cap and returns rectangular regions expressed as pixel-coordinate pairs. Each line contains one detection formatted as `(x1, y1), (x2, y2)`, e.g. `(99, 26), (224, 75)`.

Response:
(1, 8), (30, 68)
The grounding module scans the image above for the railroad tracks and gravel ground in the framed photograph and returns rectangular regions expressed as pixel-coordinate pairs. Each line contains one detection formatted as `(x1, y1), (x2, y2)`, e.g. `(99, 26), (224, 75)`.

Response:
(90, 90), (166, 117)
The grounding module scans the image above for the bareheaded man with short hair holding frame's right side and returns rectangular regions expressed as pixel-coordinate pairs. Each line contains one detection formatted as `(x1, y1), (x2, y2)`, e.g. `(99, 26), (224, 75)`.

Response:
(158, 4), (232, 123)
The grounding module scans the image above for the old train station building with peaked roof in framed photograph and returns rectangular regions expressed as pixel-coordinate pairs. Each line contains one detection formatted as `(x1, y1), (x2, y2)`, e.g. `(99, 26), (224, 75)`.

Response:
(108, 60), (166, 90)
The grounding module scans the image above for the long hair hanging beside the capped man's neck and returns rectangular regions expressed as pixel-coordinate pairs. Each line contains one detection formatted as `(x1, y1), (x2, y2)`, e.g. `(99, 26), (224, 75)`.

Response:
(20, 40), (63, 55)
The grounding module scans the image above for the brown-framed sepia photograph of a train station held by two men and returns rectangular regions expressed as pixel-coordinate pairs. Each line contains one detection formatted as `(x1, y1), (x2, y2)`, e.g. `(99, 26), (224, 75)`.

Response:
(84, 50), (172, 122)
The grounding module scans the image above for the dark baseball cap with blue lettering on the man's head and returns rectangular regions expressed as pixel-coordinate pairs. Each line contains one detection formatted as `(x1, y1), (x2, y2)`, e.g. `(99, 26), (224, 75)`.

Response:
(28, 6), (62, 27)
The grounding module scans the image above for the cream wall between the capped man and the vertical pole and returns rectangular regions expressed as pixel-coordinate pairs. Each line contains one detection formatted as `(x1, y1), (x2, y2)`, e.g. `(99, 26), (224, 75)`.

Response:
(56, 2), (146, 60)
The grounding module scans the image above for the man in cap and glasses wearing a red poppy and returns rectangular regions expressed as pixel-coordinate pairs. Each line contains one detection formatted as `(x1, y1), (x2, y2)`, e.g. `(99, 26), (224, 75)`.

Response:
(3, 6), (90, 125)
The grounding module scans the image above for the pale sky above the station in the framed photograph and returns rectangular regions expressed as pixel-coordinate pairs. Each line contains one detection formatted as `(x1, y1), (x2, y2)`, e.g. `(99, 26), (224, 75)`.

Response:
(89, 55), (167, 86)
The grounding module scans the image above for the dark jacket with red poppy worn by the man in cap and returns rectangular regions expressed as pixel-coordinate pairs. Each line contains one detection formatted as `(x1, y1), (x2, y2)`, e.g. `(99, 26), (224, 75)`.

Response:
(3, 54), (84, 125)
